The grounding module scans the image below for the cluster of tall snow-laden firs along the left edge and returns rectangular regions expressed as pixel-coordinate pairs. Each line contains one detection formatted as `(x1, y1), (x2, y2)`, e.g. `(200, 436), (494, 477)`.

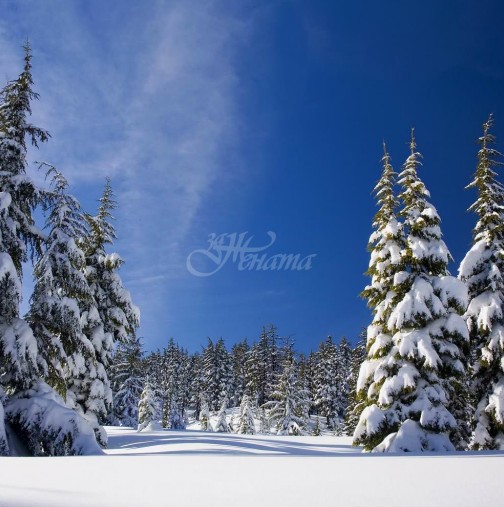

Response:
(0, 45), (139, 455)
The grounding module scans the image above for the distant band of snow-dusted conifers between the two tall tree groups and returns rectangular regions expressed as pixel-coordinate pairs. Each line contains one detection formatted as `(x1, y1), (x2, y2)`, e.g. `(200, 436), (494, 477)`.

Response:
(109, 325), (365, 434)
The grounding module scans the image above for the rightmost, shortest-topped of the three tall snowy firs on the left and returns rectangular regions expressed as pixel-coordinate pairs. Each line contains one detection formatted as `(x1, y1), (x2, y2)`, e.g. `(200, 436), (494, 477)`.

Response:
(70, 179), (140, 446)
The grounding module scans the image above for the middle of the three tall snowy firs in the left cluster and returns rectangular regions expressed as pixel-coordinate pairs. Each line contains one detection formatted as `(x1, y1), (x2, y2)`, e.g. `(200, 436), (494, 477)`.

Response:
(27, 164), (92, 398)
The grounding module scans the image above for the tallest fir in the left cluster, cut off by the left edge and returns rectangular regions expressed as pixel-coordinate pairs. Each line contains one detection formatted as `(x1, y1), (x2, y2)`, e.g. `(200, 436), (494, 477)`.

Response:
(0, 44), (49, 455)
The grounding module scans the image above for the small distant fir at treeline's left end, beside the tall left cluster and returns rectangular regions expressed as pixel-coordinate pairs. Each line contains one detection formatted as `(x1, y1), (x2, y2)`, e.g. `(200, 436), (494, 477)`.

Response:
(109, 337), (144, 428)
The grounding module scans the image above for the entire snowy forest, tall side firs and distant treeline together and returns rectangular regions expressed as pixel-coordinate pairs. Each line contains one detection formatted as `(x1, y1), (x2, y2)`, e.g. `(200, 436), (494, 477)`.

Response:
(0, 44), (504, 456)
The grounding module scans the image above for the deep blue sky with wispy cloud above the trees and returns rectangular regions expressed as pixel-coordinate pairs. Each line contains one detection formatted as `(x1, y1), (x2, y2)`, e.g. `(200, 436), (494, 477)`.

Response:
(0, 0), (504, 352)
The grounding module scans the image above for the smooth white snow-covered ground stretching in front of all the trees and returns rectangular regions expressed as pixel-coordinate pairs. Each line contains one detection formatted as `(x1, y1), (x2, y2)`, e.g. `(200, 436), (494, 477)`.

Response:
(0, 427), (504, 507)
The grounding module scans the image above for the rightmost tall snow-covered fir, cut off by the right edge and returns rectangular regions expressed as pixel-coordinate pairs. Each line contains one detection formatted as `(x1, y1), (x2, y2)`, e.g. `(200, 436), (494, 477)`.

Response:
(459, 115), (504, 449)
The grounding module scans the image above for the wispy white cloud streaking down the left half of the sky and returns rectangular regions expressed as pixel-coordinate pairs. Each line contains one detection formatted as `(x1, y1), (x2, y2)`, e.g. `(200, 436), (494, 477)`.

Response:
(0, 0), (249, 346)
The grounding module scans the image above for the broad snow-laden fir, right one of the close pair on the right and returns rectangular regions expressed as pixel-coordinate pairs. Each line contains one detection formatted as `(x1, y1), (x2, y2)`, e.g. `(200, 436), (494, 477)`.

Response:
(354, 131), (468, 451)
